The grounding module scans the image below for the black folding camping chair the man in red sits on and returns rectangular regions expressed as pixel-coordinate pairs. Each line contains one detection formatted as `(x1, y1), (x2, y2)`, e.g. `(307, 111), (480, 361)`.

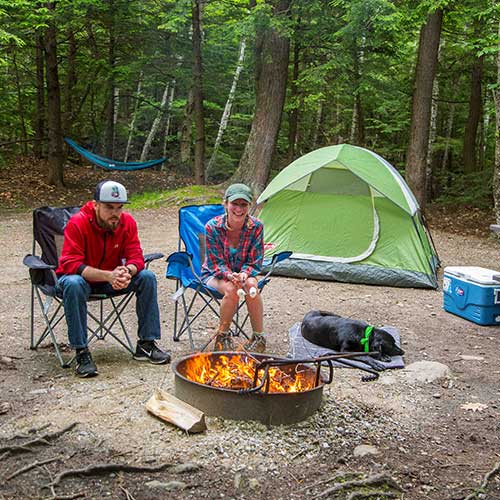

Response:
(23, 207), (163, 368)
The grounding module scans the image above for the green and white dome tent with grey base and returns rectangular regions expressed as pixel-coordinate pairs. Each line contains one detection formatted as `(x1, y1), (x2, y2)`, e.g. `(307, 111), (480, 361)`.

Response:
(257, 144), (439, 288)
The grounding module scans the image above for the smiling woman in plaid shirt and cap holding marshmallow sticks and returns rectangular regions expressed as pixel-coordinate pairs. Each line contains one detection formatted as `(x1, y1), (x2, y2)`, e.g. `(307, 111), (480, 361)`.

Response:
(202, 184), (266, 352)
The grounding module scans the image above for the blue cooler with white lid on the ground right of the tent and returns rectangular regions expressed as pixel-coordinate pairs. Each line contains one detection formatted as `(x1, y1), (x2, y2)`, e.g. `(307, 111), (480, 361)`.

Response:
(443, 267), (500, 325)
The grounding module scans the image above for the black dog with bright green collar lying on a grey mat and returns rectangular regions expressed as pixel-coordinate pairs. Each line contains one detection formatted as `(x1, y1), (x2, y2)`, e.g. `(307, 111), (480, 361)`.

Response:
(301, 311), (404, 362)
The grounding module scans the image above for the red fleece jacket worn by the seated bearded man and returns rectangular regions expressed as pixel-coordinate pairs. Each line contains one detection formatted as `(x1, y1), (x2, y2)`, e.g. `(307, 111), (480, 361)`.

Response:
(56, 201), (144, 282)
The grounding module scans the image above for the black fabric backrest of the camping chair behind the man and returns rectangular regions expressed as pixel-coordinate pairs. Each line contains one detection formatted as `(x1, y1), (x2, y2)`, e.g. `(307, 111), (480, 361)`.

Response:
(33, 207), (80, 266)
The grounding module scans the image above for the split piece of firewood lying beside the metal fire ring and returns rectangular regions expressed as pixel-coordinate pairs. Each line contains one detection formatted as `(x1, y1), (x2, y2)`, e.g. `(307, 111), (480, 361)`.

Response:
(146, 389), (207, 433)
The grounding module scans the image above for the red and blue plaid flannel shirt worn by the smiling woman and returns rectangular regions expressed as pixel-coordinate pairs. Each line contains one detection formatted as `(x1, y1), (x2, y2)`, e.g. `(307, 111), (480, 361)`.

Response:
(201, 215), (264, 280)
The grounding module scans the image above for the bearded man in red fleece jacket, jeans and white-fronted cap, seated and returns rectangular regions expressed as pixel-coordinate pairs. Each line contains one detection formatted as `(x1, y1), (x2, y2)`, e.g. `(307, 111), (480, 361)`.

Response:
(56, 181), (170, 377)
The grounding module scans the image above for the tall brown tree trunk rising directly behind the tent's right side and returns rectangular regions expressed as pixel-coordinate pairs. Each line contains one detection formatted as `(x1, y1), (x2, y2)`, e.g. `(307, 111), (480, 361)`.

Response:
(406, 9), (443, 208)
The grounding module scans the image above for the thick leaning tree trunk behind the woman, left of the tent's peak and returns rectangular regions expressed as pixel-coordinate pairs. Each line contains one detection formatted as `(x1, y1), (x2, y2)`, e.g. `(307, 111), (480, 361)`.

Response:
(232, 0), (290, 193)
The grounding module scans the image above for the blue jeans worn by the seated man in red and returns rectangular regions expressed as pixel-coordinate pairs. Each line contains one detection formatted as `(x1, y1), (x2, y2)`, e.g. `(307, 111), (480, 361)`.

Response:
(56, 269), (160, 349)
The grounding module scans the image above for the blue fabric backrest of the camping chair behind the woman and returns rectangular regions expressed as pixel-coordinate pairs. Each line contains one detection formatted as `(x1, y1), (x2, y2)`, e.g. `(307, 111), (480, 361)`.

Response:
(179, 205), (224, 272)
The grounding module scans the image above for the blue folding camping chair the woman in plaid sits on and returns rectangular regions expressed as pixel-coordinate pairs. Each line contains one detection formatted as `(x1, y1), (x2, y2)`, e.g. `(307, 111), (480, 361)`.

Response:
(166, 205), (292, 351)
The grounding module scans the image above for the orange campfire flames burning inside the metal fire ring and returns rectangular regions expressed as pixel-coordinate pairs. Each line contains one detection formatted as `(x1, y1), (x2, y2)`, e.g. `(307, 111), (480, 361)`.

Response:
(184, 354), (315, 393)
